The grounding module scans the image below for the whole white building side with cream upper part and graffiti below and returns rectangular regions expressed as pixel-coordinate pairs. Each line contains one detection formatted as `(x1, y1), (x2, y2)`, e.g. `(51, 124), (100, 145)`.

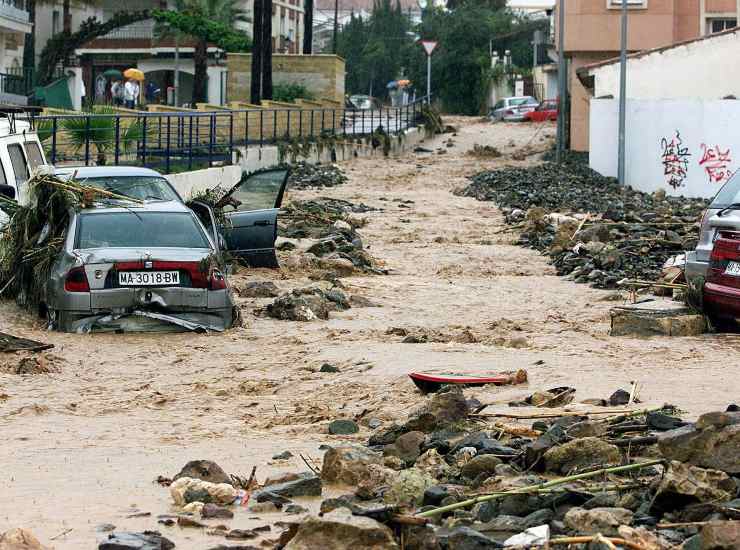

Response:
(577, 28), (740, 198)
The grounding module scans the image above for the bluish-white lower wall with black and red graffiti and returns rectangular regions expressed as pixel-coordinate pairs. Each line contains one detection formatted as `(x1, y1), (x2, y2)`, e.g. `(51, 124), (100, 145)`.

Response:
(590, 99), (740, 198)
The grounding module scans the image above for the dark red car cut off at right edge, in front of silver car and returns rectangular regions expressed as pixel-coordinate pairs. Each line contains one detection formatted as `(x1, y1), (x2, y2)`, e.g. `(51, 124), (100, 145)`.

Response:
(704, 231), (740, 329)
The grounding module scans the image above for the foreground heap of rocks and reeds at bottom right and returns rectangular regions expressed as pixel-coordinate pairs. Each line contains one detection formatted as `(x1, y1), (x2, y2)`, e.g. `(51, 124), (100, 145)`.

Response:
(153, 386), (740, 550)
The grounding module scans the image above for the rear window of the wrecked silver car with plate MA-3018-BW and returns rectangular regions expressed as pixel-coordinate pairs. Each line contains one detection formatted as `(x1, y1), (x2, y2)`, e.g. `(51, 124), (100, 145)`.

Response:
(77, 210), (210, 250)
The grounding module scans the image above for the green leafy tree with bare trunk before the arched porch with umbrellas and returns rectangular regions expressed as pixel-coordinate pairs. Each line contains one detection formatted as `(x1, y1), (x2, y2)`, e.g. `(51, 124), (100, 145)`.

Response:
(152, 0), (250, 103)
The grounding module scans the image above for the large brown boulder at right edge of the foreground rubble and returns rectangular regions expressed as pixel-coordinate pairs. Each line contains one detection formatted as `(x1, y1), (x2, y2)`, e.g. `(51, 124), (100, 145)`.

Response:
(658, 412), (740, 474)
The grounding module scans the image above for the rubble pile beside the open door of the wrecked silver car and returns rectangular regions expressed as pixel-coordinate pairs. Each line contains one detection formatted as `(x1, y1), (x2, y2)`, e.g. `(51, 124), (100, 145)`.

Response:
(278, 198), (385, 275)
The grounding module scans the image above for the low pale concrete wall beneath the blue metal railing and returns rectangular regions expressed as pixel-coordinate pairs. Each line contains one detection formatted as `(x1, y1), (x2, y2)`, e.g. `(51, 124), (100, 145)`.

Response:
(165, 128), (426, 199)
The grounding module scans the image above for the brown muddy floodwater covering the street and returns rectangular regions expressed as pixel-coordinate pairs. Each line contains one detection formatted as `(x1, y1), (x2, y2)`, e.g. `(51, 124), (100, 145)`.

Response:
(0, 119), (740, 549)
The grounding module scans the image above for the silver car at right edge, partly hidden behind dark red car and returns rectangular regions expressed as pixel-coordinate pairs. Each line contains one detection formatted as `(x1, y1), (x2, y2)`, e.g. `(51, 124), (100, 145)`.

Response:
(685, 173), (740, 282)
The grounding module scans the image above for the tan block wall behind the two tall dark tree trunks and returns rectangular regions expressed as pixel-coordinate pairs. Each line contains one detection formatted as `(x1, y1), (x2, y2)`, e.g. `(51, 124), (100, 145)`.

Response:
(228, 53), (345, 102)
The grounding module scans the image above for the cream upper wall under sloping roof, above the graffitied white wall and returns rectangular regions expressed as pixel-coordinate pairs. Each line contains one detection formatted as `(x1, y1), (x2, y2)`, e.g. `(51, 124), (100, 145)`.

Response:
(590, 31), (740, 99)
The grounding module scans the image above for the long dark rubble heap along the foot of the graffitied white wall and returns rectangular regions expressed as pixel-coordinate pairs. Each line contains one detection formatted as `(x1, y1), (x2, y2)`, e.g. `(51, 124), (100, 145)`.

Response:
(457, 160), (707, 288)
